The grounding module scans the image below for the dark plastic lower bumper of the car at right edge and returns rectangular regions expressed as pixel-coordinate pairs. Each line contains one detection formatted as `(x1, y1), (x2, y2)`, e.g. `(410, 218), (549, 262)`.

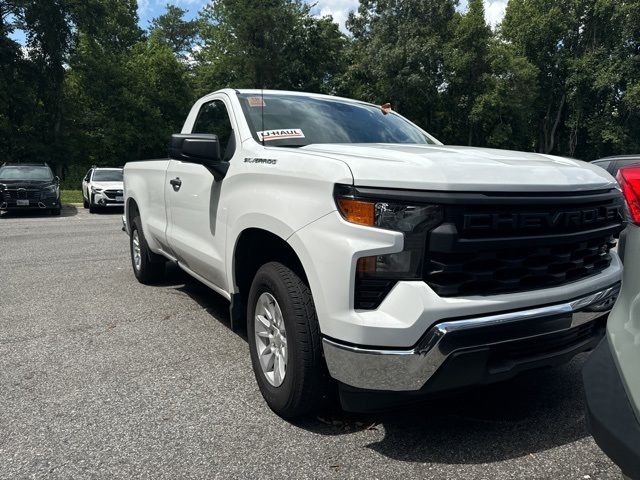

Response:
(582, 339), (640, 478)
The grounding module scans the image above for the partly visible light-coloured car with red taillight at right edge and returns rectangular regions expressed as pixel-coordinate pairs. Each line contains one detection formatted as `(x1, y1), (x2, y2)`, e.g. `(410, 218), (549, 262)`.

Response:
(583, 165), (640, 479)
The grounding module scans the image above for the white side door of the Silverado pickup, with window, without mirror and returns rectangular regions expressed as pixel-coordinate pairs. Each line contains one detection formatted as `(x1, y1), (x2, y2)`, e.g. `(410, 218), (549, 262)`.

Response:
(165, 99), (236, 292)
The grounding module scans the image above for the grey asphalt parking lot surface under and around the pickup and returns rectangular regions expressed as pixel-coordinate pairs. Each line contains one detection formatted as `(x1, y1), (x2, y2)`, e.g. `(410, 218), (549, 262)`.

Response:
(0, 206), (620, 479)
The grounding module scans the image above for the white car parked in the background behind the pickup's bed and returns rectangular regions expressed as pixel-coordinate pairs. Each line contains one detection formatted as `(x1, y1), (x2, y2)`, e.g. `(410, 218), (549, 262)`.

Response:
(82, 167), (124, 213)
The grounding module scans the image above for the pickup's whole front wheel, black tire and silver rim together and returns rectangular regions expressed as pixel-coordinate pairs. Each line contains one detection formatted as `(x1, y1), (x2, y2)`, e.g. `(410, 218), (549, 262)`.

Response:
(247, 262), (330, 417)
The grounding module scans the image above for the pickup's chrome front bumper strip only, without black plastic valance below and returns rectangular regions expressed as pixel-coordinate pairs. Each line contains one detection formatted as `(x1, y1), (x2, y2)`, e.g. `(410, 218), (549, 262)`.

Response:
(323, 284), (620, 392)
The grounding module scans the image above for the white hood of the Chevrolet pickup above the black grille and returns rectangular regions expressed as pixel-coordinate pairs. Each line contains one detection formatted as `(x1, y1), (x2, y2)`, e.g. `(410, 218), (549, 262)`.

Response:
(301, 144), (617, 192)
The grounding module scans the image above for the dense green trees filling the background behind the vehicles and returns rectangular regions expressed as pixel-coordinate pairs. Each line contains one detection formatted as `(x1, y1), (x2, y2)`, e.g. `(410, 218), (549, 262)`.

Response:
(0, 0), (640, 186)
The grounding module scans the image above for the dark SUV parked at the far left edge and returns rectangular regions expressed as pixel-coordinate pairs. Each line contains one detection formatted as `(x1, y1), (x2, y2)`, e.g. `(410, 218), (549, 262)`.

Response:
(0, 163), (60, 215)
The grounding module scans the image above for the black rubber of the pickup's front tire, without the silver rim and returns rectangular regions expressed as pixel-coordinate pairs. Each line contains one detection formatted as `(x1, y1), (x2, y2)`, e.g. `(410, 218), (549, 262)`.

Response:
(247, 262), (331, 418)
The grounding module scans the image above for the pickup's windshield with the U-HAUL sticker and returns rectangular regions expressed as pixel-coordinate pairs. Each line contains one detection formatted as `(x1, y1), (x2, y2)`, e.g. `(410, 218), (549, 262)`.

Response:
(238, 94), (434, 147)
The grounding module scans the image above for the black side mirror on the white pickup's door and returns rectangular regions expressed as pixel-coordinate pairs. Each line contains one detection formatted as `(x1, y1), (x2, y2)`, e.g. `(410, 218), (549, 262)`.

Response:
(169, 133), (229, 181)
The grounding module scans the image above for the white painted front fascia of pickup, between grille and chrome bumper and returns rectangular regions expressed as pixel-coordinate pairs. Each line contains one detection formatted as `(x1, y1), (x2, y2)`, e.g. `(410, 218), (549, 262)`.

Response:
(288, 212), (622, 350)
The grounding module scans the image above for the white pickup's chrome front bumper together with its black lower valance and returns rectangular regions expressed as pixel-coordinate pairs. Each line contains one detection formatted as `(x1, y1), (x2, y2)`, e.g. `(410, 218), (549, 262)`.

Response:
(323, 283), (620, 392)
